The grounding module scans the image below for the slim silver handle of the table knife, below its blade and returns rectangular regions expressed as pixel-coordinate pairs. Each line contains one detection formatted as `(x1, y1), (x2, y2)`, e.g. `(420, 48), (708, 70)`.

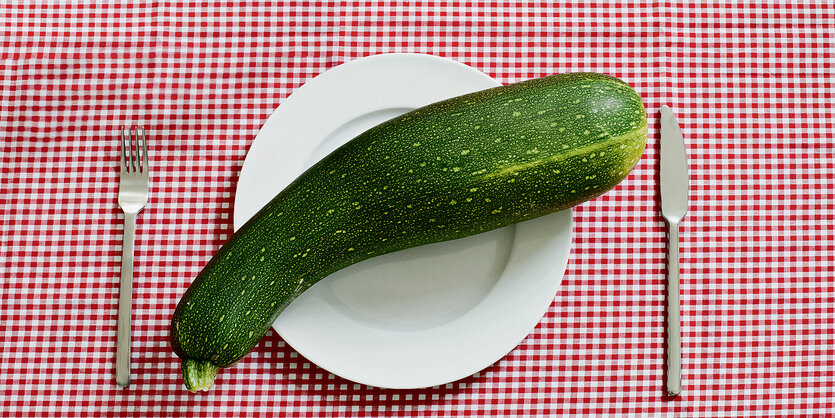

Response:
(667, 221), (681, 396)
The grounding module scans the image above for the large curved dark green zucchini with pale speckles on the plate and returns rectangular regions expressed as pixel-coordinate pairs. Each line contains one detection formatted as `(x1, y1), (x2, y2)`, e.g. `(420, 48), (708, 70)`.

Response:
(170, 73), (647, 391)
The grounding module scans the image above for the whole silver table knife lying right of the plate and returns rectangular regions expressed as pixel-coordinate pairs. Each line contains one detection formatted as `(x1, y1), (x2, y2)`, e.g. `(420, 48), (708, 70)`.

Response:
(661, 105), (688, 396)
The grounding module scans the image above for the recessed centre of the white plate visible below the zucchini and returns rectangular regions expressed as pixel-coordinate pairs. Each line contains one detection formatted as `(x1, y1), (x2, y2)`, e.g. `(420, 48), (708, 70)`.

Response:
(320, 226), (515, 332)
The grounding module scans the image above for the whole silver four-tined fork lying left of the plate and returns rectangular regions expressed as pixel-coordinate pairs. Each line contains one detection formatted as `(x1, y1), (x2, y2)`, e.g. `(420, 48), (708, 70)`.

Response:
(116, 127), (148, 387)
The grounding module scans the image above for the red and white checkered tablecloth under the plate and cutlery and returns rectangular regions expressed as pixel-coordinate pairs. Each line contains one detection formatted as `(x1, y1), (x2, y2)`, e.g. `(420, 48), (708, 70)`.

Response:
(0, 0), (835, 417)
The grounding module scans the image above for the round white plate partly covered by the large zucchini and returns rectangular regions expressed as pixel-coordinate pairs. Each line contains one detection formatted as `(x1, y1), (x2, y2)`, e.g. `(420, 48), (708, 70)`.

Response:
(234, 54), (571, 388)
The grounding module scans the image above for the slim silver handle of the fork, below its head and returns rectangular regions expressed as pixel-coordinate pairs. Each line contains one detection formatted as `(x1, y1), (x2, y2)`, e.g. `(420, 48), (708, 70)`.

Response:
(116, 212), (137, 387)
